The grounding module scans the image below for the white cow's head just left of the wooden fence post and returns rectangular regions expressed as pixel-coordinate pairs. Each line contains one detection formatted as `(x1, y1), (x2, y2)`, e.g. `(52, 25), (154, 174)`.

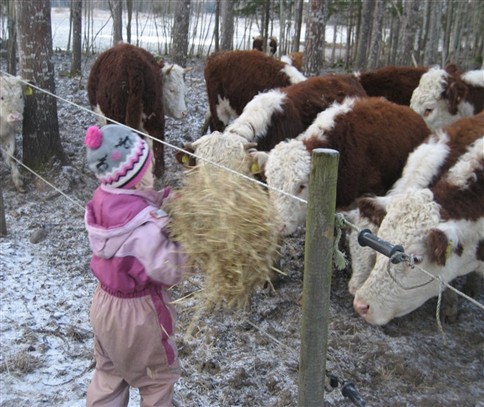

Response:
(251, 139), (311, 235)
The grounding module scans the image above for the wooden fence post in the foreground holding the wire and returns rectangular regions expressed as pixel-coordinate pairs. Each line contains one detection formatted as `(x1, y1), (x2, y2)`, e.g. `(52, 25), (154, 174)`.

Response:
(298, 149), (339, 407)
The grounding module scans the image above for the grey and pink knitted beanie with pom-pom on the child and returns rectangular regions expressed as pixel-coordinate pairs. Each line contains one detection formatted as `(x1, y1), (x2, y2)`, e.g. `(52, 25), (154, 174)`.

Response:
(84, 124), (152, 189)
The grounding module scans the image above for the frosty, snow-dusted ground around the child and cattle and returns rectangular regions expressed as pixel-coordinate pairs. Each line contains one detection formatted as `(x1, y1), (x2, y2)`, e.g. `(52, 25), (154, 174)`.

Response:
(0, 54), (484, 407)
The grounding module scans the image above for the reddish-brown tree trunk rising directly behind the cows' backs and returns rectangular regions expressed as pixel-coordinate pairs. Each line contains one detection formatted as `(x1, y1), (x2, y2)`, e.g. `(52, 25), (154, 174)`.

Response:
(303, 0), (327, 75)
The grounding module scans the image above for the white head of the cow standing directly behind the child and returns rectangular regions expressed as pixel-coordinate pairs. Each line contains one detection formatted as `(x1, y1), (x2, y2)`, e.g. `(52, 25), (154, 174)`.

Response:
(161, 64), (192, 119)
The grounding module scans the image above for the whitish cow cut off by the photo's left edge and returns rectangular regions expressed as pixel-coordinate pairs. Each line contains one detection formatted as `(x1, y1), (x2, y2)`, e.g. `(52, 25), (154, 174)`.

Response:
(0, 75), (25, 192)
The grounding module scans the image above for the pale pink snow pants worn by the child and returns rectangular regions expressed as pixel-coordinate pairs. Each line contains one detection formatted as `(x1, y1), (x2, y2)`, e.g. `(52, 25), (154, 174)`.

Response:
(87, 287), (180, 407)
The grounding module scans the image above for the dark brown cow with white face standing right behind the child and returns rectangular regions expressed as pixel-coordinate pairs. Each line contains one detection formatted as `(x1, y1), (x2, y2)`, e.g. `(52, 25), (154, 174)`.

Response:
(87, 44), (189, 177)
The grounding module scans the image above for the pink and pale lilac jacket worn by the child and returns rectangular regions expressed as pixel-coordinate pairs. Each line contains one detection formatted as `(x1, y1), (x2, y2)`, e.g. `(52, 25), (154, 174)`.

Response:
(85, 185), (186, 364)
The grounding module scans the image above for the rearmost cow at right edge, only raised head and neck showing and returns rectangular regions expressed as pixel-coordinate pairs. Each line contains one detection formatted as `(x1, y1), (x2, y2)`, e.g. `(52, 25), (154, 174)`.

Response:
(410, 64), (484, 130)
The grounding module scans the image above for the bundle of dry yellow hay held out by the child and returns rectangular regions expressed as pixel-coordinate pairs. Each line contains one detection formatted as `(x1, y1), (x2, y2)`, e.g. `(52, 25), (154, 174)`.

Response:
(166, 165), (279, 308)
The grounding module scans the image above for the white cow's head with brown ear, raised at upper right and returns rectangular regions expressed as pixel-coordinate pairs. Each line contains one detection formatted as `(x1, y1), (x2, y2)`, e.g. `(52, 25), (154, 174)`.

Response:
(410, 66), (474, 131)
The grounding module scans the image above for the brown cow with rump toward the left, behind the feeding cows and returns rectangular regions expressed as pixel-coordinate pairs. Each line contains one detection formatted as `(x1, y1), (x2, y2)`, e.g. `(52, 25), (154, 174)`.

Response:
(204, 50), (306, 131)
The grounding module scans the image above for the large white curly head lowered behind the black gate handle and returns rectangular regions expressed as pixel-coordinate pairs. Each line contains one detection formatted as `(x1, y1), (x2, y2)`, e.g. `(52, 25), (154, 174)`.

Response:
(353, 189), (484, 325)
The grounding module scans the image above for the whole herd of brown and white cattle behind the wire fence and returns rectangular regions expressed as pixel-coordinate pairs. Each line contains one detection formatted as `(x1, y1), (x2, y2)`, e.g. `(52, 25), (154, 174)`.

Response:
(0, 44), (484, 325)
